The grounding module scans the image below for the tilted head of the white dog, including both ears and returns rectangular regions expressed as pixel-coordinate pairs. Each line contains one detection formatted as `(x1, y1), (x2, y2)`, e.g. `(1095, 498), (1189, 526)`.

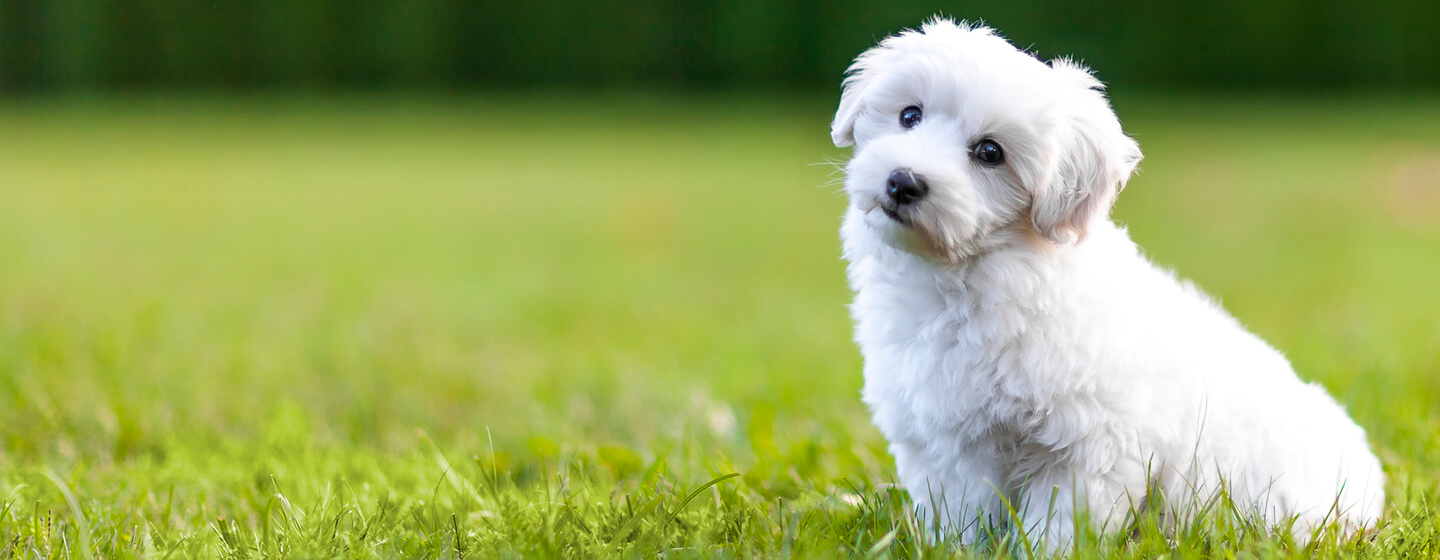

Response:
(831, 19), (1140, 262)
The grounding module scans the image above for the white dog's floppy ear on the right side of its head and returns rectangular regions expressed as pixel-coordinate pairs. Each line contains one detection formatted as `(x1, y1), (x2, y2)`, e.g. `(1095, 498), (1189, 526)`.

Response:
(1030, 60), (1142, 243)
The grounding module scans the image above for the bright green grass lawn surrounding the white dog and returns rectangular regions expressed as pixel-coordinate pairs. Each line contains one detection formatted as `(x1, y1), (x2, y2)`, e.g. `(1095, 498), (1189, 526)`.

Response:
(0, 96), (1440, 559)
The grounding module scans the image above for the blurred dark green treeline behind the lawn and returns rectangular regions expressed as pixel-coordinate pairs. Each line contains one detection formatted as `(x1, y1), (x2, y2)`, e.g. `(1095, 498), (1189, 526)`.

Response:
(0, 0), (1440, 92)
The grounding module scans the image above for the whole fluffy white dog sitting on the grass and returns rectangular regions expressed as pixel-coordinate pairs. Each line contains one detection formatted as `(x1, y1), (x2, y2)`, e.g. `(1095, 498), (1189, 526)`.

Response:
(831, 19), (1384, 547)
